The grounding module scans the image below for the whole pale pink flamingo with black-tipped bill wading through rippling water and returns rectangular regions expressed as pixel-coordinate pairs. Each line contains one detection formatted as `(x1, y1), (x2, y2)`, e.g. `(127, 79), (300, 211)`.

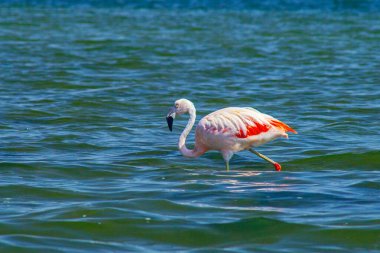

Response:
(166, 98), (297, 171)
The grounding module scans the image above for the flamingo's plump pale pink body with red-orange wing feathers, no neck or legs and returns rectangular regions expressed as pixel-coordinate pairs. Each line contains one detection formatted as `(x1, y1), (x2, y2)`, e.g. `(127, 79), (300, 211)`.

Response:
(195, 107), (295, 152)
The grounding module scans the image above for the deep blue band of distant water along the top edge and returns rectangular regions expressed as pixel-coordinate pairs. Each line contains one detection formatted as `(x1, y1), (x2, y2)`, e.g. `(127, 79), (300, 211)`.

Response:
(3, 0), (380, 11)
